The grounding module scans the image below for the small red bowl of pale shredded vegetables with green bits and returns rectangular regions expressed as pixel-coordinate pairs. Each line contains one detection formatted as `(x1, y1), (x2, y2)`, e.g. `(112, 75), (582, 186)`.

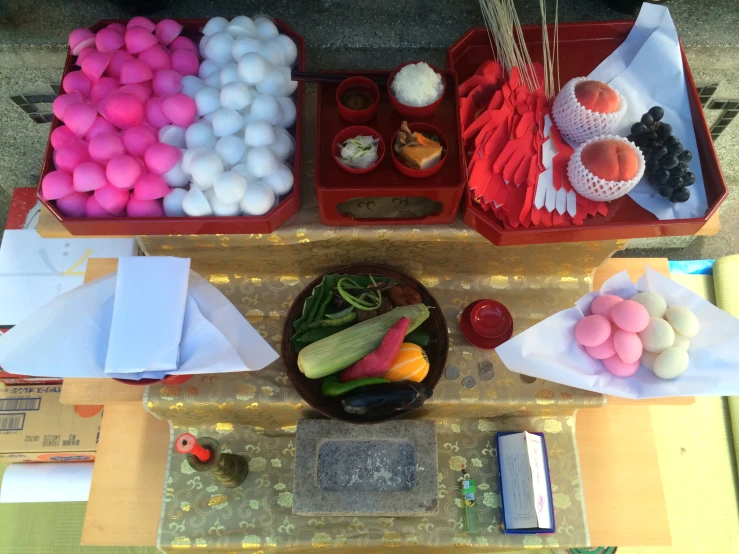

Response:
(331, 125), (385, 175)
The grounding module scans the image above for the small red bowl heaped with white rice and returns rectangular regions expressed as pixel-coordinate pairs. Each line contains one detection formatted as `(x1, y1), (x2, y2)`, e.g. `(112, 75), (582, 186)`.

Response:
(387, 62), (445, 117)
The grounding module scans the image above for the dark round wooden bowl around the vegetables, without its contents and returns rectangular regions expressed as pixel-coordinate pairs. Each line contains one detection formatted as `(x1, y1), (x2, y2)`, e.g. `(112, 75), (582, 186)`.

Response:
(282, 265), (449, 423)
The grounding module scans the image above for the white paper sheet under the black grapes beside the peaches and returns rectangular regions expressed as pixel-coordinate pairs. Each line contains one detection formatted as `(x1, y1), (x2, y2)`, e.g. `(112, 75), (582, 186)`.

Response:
(588, 3), (708, 219)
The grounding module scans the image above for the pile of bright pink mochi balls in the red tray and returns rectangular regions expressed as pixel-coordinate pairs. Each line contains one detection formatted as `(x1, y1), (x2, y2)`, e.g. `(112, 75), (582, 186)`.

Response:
(41, 17), (200, 218)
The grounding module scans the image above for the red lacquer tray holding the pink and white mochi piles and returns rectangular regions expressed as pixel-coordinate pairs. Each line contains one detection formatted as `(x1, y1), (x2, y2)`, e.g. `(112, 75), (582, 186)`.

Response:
(38, 19), (305, 235)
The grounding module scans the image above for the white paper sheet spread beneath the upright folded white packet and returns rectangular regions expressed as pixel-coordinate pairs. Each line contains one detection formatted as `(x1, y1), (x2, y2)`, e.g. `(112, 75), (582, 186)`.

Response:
(0, 258), (278, 380)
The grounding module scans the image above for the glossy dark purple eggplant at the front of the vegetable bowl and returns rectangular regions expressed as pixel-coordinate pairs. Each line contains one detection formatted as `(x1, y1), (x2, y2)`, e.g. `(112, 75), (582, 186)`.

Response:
(341, 381), (431, 418)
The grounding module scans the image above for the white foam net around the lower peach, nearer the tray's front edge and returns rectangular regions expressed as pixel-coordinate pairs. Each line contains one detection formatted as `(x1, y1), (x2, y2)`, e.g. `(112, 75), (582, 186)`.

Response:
(567, 135), (645, 202)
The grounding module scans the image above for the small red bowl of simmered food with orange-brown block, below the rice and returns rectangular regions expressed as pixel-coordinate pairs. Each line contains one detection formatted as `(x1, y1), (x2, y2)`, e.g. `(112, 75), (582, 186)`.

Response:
(391, 121), (447, 179)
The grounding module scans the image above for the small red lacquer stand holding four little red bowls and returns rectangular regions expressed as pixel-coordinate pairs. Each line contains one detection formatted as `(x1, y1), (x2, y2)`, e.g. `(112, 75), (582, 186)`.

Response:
(315, 70), (467, 225)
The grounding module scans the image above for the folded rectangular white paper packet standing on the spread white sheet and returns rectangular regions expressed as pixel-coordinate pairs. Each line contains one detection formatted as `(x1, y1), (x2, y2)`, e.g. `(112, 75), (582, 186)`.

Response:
(105, 256), (190, 373)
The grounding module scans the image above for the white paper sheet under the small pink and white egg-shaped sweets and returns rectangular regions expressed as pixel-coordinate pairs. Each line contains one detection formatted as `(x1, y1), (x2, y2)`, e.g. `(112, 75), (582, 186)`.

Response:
(496, 267), (739, 398)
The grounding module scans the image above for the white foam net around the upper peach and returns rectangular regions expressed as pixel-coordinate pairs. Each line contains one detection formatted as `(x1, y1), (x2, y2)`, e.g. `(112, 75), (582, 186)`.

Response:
(552, 77), (627, 147)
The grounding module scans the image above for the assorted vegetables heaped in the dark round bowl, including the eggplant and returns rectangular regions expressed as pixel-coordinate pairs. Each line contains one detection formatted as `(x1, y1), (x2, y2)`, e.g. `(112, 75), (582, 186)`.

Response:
(291, 274), (431, 417)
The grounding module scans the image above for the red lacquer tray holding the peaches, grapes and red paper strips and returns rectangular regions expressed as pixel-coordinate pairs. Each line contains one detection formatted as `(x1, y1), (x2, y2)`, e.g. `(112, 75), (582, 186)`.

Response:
(447, 21), (728, 246)
